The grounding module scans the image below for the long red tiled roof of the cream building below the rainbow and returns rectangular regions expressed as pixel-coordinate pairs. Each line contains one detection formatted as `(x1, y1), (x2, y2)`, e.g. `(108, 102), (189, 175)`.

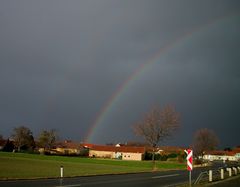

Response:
(90, 145), (145, 153)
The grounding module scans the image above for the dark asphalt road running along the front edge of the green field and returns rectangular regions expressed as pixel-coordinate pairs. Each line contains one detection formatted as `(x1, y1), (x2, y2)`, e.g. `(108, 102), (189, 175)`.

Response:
(0, 168), (206, 187)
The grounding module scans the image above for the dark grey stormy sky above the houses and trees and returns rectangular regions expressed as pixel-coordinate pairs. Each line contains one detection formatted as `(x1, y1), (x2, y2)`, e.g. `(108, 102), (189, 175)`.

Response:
(0, 0), (240, 146)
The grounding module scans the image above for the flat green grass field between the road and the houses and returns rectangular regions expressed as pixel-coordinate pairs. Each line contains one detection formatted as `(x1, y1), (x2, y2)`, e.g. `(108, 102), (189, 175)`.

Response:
(0, 152), (186, 180)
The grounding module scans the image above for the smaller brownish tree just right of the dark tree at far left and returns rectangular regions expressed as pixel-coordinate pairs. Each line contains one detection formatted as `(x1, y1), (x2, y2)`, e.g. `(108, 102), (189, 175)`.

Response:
(38, 129), (57, 149)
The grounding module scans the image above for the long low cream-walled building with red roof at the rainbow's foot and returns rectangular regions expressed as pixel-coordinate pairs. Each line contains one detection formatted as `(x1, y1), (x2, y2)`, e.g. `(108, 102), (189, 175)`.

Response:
(89, 145), (145, 161)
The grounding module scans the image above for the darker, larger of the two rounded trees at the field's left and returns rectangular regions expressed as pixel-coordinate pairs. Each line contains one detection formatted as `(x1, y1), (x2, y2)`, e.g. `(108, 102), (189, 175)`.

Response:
(12, 126), (35, 151)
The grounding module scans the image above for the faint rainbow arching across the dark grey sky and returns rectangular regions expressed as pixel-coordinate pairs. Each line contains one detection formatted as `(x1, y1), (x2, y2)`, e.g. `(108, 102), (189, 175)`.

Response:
(85, 13), (239, 143)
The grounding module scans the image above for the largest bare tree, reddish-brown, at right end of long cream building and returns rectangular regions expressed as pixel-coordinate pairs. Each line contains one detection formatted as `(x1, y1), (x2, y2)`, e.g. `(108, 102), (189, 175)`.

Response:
(134, 106), (180, 161)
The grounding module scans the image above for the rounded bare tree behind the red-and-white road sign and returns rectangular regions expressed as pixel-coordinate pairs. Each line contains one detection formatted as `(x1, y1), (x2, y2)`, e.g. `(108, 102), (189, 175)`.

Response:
(193, 128), (219, 156)
